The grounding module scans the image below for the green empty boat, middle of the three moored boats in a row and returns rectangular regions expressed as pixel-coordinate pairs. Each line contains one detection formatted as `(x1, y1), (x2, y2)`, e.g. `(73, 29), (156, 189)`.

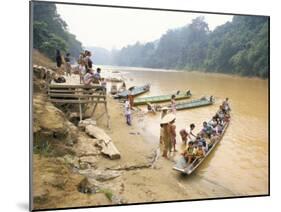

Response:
(134, 90), (191, 106)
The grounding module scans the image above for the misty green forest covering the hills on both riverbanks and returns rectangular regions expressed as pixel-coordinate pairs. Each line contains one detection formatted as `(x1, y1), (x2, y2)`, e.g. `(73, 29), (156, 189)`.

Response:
(33, 2), (269, 78)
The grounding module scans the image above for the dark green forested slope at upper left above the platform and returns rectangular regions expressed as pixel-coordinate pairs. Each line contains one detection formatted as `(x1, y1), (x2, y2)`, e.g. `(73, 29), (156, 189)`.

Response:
(33, 2), (82, 60)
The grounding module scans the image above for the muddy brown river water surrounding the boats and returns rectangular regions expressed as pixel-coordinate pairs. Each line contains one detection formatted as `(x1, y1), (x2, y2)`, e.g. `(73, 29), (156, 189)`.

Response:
(103, 67), (268, 197)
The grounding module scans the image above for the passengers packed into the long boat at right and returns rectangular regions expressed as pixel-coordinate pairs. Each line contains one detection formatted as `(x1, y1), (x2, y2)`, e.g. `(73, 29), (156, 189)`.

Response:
(180, 98), (230, 164)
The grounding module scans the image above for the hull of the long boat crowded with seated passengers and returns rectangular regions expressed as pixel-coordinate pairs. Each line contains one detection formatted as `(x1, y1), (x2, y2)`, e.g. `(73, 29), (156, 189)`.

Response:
(173, 113), (230, 175)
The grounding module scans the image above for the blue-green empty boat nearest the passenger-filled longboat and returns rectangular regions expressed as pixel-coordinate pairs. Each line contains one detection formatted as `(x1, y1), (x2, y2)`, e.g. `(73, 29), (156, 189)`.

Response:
(160, 96), (215, 110)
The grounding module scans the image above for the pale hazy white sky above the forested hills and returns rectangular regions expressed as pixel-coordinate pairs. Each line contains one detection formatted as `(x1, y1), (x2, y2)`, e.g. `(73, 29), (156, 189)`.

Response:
(57, 4), (233, 50)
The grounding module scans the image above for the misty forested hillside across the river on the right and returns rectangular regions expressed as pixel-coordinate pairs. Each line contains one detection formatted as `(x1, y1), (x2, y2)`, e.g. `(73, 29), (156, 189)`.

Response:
(111, 16), (269, 78)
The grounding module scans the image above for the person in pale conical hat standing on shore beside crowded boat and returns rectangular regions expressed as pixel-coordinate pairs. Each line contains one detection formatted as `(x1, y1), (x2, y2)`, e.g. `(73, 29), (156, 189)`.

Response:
(161, 113), (176, 159)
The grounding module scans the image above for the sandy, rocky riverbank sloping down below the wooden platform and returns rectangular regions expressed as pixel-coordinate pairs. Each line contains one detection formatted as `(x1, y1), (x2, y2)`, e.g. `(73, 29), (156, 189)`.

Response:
(33, 51), (195, 209)
